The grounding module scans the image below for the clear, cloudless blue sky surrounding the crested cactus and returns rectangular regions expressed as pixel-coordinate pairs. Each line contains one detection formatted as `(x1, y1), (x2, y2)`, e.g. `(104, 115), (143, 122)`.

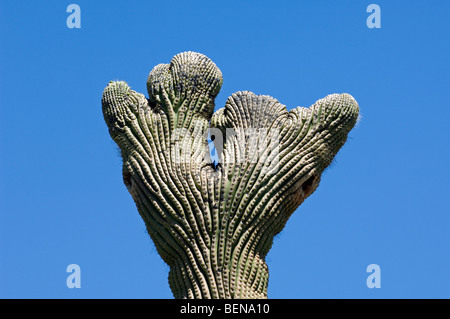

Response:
(0, 0), (450, 298)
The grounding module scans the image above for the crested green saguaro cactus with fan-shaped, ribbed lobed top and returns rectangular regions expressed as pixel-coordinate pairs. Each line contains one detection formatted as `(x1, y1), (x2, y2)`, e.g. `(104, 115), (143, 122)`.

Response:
(102, 52), (359, 298)
